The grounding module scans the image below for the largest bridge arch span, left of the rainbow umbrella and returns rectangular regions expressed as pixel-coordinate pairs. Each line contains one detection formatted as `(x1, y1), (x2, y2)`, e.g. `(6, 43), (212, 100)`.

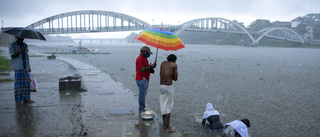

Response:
(27, 10), (152, 34)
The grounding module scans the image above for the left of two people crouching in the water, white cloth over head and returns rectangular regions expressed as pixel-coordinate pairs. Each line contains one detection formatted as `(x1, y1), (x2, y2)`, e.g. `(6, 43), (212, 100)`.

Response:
(202, 103), (223, 131)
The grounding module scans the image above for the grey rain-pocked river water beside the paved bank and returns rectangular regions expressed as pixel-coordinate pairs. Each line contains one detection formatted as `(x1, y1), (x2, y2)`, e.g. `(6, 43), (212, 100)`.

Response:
(30, 43), (320, 137)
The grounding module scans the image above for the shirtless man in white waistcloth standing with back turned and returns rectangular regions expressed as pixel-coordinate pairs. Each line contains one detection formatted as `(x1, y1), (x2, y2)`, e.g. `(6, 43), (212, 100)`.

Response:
(160, 54), (178, 132)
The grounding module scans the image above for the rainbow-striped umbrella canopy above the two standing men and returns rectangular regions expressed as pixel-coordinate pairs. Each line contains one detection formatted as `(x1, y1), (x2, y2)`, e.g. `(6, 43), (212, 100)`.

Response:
(135, 28), (184, 51)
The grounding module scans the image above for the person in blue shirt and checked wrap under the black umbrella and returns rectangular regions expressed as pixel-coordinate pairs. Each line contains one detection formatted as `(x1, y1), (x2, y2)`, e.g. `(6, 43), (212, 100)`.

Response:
(9, 37), (34, 105)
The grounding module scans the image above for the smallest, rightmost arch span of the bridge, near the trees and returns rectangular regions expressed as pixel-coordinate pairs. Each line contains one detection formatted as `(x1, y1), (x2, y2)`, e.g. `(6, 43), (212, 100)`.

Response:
(254, 27), (304, 44)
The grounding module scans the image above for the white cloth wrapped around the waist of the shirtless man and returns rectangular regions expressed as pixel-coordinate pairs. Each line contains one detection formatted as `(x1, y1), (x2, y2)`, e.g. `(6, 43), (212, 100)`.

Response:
(160, 85), (174, 115)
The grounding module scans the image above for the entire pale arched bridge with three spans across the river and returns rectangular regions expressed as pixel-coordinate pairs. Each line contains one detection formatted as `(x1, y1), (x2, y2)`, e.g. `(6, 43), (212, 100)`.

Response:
(27, 10), (304, 44)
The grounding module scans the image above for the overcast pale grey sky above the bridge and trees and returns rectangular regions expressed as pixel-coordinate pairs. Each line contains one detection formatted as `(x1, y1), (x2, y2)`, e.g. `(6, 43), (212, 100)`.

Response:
(0, 0), (320, 37)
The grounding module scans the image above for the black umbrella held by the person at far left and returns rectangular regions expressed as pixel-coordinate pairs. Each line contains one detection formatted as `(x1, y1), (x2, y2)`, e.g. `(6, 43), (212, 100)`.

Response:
(2, 27), (46, 40)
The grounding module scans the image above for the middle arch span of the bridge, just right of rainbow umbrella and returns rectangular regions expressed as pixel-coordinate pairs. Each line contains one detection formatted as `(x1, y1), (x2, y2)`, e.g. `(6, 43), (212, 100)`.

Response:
(176, 17), (255, 42)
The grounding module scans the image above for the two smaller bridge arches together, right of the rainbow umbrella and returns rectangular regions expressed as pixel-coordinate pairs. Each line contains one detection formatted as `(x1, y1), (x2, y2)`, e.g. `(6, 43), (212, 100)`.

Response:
(176, 17), (304, 44)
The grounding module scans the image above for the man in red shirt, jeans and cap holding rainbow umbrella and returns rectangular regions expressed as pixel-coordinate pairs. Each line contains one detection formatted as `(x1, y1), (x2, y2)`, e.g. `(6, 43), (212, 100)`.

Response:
(136, 46), (157, 113)
